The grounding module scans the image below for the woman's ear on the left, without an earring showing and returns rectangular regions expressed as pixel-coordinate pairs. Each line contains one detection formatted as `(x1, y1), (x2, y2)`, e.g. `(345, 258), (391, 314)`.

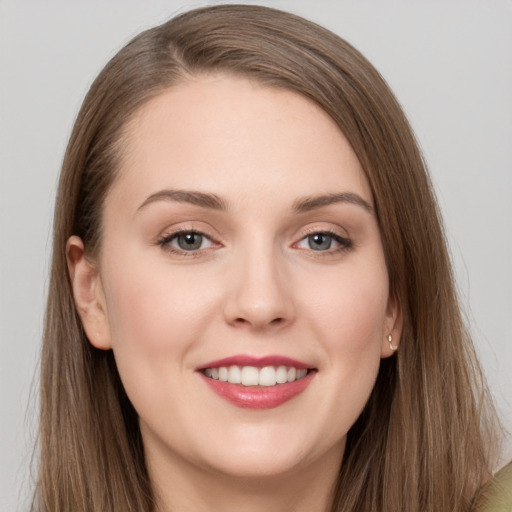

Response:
(66, 236), (112, 350)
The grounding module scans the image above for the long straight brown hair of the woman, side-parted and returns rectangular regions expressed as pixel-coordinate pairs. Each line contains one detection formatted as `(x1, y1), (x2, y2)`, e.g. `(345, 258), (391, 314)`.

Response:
(34, 5), (495, 512)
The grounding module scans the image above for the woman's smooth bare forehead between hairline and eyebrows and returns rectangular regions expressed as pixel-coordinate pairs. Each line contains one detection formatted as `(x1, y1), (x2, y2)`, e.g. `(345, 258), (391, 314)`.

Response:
(111, 75), (372, 213)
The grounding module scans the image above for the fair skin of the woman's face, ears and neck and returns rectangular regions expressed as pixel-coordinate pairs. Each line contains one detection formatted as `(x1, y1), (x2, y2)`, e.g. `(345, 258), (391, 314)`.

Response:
(67, 75), (401, 512)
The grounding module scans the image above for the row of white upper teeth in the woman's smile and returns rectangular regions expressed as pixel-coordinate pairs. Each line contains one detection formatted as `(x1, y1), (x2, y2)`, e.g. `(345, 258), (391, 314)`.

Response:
(203, 366), (308, 387)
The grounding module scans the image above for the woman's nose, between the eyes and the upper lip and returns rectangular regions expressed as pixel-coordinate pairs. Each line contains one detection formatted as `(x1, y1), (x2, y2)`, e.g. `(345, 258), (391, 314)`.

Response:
(224, 245), (295, 331)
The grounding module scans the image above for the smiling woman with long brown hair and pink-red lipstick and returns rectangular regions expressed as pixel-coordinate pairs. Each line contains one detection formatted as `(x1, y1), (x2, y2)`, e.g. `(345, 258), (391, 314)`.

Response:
(36, 6), (504, 512)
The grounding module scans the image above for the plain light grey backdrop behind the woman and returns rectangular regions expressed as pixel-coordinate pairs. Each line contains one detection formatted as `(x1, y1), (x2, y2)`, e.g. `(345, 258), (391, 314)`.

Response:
(0, 0), (512, 512)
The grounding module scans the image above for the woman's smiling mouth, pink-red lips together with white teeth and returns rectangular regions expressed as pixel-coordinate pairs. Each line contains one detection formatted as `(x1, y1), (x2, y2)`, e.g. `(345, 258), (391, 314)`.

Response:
(197, 356), (317, 409)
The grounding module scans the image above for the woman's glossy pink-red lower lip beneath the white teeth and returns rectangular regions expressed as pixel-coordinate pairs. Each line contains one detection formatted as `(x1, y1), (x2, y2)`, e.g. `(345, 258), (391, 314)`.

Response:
(200, 371), (316, 409)
